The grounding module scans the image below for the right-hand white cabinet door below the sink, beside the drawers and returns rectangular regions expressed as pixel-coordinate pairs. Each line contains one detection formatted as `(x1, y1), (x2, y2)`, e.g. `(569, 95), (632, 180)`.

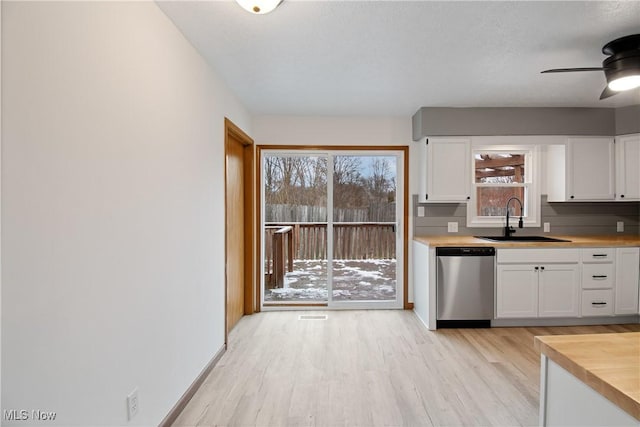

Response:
(538, 264), (580, 317)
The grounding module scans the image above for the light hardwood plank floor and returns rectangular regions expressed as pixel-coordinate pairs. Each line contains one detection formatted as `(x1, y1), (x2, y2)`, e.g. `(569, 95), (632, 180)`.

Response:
(174, 310), (640, 426)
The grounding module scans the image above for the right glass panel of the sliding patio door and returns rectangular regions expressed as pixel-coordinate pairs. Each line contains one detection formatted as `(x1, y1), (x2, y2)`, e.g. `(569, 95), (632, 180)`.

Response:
(330, 154), (398, 302)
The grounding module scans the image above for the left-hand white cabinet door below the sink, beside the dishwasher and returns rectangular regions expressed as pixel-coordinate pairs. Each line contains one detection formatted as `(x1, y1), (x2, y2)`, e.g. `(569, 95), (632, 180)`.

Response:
(496, 264), (538, 319)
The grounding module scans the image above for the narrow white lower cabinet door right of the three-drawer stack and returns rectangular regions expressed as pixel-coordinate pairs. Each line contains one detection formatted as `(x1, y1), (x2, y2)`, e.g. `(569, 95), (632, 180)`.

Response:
(614, 248), (640, 314)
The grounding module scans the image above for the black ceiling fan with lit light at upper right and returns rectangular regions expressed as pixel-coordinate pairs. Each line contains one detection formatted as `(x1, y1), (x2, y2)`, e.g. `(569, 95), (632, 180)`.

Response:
(542, 34), (640, 99)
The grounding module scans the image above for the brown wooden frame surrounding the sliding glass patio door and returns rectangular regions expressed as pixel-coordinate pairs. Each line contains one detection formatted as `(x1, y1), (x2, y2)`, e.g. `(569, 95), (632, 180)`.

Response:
(254, 145), (413, 311)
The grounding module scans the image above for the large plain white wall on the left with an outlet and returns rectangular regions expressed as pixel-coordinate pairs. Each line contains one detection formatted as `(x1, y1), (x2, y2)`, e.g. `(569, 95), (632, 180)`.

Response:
(2, 2), (251, 426)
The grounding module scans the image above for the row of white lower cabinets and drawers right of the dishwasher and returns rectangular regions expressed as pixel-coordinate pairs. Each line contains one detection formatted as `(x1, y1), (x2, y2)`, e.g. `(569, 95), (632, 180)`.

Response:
(496, 247), (640, 319)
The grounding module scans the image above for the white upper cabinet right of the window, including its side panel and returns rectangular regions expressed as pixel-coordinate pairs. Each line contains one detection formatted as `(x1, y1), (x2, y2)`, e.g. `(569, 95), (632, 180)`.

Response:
(547, 137), (615, 202)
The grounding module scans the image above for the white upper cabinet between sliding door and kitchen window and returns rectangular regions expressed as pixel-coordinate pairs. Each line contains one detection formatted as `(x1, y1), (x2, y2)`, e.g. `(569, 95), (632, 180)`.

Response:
(419, 138), (471, 203)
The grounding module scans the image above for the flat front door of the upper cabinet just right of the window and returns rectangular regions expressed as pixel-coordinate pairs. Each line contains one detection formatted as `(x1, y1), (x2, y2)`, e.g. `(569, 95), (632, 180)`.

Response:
(567, 137), (615, 201)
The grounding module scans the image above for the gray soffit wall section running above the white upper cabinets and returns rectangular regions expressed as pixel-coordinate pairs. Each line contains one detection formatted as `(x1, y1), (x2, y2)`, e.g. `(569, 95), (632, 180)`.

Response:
(412, 106), (628, 141)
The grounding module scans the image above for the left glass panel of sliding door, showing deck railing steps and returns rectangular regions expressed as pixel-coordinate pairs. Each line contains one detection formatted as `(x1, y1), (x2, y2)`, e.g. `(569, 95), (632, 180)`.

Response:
(262, 153), (328, 303)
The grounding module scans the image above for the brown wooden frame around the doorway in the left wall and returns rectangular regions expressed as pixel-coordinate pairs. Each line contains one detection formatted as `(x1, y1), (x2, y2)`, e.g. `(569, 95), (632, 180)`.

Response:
(224, 117), (259, 346)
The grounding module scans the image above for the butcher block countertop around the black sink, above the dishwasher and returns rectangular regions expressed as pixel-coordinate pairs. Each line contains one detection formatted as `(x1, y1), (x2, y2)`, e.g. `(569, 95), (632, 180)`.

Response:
(413, 233), (640, 248)
